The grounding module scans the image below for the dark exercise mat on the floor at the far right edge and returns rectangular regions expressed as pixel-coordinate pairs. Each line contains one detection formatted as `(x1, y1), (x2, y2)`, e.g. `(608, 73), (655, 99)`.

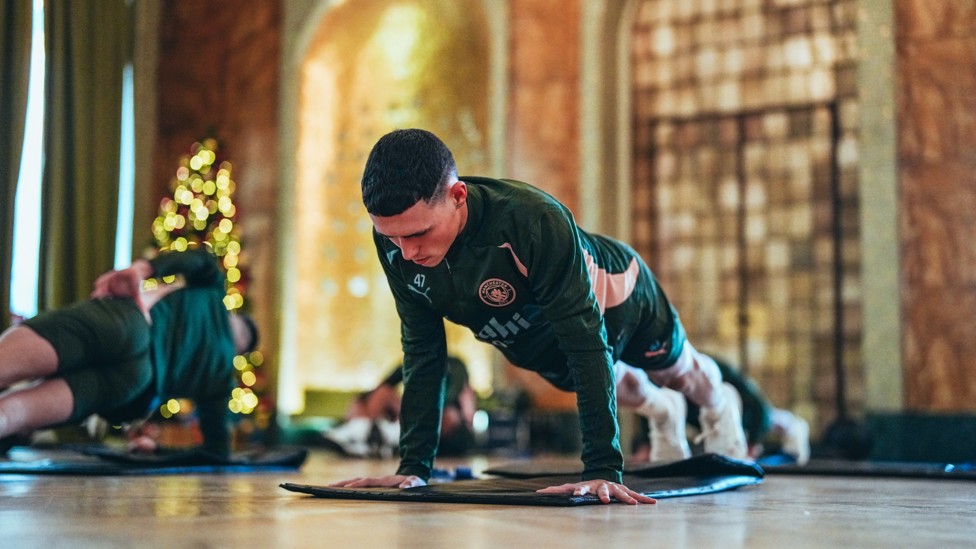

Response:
(762, 459), (976, 480)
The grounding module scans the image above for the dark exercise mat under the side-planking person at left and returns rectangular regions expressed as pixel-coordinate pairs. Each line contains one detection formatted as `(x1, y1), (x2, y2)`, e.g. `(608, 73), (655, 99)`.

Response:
(0, 446), (308, 475)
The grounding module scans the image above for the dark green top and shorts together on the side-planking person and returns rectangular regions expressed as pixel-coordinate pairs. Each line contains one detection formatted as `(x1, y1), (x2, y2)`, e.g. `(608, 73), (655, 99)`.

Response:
(24, 249), (235, 454)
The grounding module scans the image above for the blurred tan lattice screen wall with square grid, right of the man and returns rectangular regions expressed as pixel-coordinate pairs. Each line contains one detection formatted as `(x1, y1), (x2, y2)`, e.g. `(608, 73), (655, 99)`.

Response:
(631, 0), (864, 424)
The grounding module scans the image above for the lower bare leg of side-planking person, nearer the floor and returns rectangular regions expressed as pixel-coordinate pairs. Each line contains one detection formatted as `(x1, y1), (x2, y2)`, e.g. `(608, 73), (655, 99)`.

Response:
(0, 378), (75, 438)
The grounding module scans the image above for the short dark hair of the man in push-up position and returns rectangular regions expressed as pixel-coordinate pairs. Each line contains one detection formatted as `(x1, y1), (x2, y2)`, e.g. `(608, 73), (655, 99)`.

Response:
(362, 129), (457, 217)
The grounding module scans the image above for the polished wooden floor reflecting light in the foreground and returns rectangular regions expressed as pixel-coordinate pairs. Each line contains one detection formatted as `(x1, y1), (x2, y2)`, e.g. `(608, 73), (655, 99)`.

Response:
(0, 452), (976, 549)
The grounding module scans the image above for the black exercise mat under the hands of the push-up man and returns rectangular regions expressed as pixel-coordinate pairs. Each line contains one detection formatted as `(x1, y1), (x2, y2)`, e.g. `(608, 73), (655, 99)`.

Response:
(281, 455), (763, 507)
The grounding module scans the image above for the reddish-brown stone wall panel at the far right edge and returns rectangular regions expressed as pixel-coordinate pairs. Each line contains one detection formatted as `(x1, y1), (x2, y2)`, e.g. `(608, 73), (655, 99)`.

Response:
(895, 0), (976, 412)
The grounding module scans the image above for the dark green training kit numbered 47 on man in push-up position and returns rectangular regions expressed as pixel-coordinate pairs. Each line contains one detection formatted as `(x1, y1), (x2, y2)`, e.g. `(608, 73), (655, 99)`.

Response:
(373, 177), (684, 482)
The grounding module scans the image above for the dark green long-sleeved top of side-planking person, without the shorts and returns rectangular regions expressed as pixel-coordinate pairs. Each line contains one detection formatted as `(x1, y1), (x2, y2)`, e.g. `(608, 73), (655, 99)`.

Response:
(149, 249), (236, 454)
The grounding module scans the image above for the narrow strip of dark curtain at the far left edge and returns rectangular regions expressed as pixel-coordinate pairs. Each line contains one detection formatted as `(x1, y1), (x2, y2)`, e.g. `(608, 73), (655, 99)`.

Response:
(0, 0), (32, 330)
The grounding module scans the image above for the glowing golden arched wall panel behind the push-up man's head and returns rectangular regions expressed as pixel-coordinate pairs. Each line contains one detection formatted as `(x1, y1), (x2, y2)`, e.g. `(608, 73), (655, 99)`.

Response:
(294, 0), (492, 390)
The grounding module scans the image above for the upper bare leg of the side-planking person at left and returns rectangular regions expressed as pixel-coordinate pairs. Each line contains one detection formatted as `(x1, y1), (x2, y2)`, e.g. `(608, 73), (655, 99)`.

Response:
(0, 326), (58, 390)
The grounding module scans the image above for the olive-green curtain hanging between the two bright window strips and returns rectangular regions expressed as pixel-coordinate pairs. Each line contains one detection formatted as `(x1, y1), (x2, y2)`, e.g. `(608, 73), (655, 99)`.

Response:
(39, 0), (131, 310)
